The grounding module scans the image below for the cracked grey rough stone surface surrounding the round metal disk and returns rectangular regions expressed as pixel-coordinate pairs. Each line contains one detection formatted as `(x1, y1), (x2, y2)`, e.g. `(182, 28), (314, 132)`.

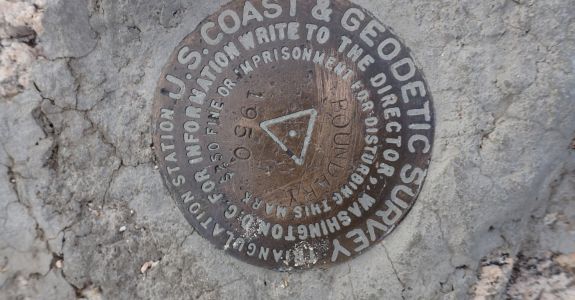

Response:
(0, 0), (575, 299)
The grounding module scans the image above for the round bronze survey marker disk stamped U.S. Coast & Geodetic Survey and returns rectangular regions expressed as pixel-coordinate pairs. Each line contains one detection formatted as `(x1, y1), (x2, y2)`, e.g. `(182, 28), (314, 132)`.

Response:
(153, 0), (434, 271)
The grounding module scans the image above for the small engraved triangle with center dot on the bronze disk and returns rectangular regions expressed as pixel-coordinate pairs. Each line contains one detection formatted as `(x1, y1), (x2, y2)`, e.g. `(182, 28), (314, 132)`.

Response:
(260, 109), (317, 166)
